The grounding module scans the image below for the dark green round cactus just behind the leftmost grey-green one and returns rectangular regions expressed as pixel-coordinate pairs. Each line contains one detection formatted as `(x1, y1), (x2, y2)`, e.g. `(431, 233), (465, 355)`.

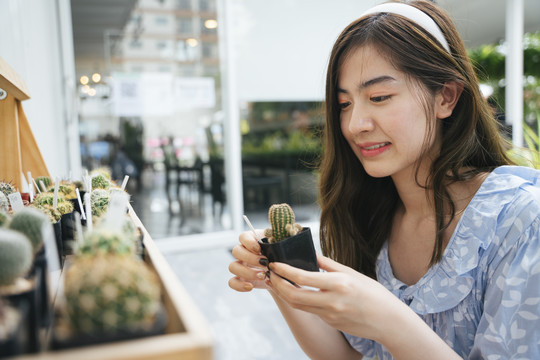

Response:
(9, 207), (52, 253)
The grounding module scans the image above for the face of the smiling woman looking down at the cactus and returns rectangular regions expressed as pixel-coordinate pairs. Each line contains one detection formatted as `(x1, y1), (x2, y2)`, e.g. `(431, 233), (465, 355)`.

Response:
(338, 46), (434, 177)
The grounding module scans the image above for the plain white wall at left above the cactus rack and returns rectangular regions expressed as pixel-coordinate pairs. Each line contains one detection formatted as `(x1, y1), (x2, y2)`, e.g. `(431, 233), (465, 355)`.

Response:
(0, 0), (80, 181)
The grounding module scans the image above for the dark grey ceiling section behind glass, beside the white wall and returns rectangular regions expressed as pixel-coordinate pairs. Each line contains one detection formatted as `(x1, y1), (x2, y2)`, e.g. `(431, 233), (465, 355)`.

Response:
(71, 0), (138, 61)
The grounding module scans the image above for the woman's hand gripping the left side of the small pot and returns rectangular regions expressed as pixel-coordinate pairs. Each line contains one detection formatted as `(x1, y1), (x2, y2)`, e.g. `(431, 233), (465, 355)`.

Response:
(229, 231), (268, 292)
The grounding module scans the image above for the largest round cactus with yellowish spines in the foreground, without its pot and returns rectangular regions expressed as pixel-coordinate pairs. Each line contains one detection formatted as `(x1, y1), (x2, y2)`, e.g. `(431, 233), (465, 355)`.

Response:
(64, 255), (161, 334)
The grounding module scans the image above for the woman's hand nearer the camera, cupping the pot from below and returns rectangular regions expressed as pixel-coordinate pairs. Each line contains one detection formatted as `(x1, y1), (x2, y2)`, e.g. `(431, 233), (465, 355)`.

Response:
(267, 255), (404, 340)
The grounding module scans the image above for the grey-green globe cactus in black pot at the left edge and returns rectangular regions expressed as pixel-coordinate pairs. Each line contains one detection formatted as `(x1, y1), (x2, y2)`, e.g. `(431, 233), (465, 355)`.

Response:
(0, 229), (41, 355)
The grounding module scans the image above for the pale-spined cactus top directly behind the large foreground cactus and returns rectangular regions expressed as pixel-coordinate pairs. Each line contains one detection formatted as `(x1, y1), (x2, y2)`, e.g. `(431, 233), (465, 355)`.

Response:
(77, 226), (135, 256)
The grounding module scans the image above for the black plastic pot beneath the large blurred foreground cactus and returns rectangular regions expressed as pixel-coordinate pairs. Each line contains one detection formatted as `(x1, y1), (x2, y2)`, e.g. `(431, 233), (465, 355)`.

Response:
(51, 306), (168, 350)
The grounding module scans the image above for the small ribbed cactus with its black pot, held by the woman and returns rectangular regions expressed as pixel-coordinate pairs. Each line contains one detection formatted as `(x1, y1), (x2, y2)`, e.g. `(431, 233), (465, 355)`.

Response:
(259, 203), (319, 271)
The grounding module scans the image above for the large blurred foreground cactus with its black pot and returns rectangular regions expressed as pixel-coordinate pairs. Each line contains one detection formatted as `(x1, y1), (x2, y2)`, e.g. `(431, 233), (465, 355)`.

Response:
(52, 254), (167, 349)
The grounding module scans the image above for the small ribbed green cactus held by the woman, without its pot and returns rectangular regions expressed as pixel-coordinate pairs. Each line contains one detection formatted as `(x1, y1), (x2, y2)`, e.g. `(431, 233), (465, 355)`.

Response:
(264, 203), (302, 243)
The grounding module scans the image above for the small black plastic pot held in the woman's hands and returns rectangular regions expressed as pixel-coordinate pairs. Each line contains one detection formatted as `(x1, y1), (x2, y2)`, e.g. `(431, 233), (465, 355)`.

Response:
(259, 228), (319, 271)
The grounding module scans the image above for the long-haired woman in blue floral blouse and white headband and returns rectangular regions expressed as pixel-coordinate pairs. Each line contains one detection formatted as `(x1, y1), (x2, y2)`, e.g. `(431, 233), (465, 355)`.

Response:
(229, 1), (540, 359)
